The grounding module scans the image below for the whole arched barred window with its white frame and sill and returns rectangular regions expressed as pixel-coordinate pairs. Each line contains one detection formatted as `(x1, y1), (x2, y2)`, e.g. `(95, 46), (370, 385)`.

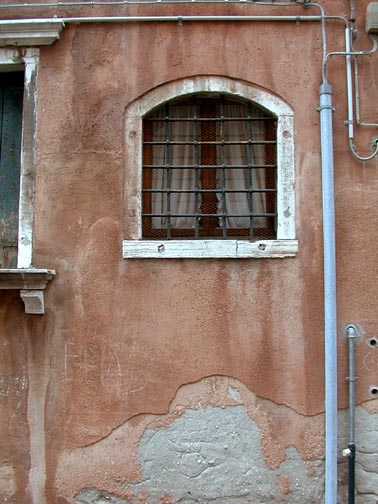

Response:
(123, 77), (297, 258)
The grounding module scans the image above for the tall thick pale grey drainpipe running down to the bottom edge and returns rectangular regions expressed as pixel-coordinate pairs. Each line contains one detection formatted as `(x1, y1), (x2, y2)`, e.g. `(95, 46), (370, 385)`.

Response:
(319, 82), (337, 504)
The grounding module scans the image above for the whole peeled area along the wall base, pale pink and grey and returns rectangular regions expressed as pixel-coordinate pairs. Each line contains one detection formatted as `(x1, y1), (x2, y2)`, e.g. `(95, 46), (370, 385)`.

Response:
(56, 376), (378, 504)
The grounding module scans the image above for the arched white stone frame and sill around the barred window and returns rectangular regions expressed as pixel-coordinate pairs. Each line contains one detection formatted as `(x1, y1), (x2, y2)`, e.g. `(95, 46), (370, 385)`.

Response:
(123, 76), (298, 259)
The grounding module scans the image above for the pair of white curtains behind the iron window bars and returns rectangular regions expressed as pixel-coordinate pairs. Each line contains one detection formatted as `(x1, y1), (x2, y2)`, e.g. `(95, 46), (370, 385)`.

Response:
(152, 102), (266, 229)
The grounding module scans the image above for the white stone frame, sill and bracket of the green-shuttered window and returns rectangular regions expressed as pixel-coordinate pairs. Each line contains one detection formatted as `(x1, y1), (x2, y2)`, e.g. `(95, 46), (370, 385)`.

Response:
(0, 49), (55, 315)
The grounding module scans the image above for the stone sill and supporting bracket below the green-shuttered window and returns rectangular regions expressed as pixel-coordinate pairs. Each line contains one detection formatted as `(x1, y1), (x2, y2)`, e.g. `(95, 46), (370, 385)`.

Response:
(0, 268), (55, 315)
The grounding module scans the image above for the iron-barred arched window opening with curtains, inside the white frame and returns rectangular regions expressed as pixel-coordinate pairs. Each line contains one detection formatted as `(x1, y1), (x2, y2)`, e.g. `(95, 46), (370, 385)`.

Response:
(142, 95), (277, 240)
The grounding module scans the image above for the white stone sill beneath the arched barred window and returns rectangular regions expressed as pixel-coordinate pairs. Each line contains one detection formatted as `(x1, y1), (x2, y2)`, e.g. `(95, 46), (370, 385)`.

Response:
(123, 240), (298, 259)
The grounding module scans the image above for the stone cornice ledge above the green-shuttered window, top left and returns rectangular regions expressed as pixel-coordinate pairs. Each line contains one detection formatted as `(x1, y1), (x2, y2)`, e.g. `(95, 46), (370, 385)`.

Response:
(0, 19), (64, 47)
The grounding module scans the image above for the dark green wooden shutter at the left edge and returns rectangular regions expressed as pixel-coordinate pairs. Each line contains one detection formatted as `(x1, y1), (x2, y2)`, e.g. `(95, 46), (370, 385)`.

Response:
(0, 72), (24, 268)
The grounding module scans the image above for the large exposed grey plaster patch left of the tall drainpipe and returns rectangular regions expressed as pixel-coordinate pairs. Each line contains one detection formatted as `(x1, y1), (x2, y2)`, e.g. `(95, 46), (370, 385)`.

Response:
(115, 405), (322, 504)
